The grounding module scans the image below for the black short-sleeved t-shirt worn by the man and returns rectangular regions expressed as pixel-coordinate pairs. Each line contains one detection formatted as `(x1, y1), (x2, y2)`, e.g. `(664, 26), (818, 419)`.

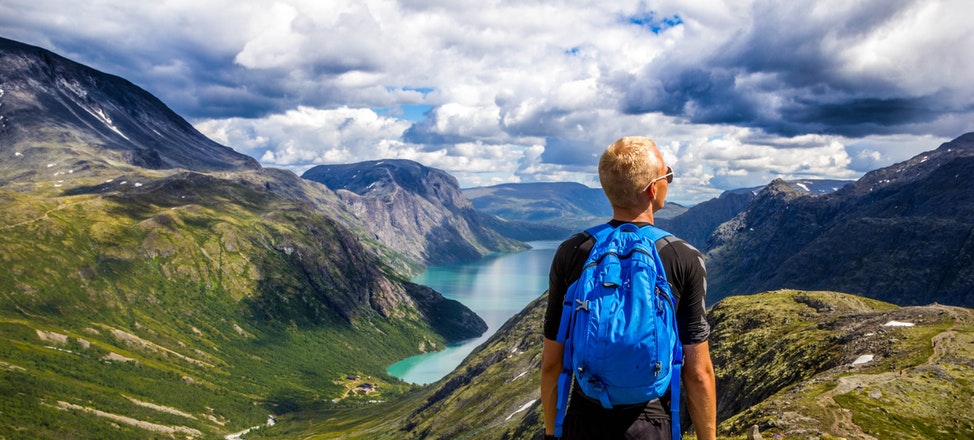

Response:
(544, 220), (710, 416)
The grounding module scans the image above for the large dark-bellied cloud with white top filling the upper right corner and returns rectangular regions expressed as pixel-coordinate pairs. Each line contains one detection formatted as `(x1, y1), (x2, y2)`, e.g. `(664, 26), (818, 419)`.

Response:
(614, 0), (974, 137)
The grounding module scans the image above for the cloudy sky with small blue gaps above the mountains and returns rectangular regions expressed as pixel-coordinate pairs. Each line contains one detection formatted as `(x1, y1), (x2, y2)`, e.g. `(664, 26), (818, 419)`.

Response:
(0, 0), (974, 205)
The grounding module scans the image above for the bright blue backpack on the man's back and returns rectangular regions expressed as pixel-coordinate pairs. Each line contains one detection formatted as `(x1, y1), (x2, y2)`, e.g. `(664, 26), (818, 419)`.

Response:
(555, 223), (683, 439)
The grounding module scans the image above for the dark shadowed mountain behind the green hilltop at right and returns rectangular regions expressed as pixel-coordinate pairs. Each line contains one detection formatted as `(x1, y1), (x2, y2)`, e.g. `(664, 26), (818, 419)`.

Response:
(707, 133), (974, 306)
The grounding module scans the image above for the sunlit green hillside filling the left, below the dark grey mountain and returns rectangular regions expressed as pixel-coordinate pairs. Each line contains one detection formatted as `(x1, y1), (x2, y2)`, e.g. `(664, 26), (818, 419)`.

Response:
(0, 173), (482, 439)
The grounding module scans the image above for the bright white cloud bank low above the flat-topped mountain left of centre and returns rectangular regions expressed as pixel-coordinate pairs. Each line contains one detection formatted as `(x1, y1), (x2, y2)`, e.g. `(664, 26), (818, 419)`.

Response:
(196, 107), (544, 186)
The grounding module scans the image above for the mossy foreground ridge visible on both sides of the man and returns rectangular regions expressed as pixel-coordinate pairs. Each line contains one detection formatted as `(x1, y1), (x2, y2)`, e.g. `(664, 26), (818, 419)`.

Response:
(250, 290), (974, 440)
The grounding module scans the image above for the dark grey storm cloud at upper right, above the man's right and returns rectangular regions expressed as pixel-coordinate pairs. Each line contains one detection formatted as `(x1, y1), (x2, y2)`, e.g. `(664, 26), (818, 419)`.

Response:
(616, 1), (968, 137)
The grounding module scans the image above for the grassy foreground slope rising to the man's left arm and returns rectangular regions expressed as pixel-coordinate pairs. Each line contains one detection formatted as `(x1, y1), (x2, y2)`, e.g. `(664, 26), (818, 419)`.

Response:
(241, 296), (547, 440)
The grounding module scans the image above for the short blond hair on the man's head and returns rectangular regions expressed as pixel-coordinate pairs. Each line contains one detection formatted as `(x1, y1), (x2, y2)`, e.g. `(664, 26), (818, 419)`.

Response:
(599, 136), (663, 209)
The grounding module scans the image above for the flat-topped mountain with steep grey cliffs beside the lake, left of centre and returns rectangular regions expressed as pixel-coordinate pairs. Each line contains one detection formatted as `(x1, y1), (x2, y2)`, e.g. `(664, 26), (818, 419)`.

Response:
(302, 160), (525, 265)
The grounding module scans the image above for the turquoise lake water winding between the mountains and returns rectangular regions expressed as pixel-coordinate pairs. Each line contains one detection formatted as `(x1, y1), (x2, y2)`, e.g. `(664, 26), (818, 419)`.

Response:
(387, 241), (560, 384)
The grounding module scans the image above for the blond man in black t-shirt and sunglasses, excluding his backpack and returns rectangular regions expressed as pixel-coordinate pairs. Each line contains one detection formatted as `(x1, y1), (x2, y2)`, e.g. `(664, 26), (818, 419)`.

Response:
(541, 137), (717, 440)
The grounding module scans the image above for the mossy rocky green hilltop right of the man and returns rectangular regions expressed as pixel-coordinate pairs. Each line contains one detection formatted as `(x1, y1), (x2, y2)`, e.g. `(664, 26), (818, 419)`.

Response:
(711, 291), (974, 439)
